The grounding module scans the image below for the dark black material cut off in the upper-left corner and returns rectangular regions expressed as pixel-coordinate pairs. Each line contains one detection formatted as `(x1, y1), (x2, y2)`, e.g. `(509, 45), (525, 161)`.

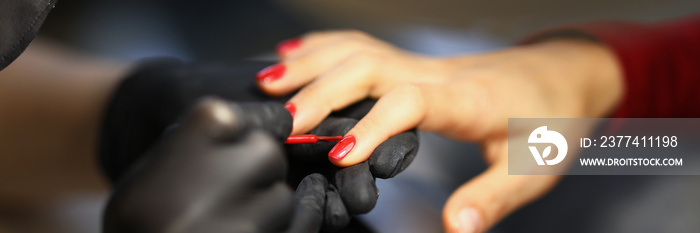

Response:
(0, 0), (57, 70)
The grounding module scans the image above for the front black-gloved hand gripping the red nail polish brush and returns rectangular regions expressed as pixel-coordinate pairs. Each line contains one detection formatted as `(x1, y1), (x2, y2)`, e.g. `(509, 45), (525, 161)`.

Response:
(103, 98), (327, 233)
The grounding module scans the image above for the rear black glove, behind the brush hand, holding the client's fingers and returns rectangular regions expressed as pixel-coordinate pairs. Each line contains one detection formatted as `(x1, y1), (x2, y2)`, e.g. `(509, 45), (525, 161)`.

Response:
(100, 59), (417, 230)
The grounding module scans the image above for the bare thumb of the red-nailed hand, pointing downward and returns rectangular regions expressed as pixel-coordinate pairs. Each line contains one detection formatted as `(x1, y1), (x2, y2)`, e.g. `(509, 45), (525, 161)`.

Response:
(442, 141), (560, 233)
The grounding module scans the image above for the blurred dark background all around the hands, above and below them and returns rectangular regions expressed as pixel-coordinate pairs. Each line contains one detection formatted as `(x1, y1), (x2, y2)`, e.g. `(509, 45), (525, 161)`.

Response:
(5, 0), (700, 233)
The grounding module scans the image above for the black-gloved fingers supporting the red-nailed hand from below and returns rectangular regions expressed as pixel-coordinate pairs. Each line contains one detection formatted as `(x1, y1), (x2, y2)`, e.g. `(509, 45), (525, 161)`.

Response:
(287, 117), (418, 232)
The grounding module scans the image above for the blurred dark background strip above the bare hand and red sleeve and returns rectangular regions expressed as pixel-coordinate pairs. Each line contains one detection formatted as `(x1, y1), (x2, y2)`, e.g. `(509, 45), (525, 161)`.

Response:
(42, 0), (700, 60)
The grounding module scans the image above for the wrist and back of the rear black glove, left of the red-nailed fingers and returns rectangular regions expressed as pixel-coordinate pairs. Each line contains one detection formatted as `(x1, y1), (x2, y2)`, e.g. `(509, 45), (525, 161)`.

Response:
(99, 58), (288, 182)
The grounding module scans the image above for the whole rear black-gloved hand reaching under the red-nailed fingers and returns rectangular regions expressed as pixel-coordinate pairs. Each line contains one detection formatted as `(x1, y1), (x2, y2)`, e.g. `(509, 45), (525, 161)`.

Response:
(100, 59), (418, 232)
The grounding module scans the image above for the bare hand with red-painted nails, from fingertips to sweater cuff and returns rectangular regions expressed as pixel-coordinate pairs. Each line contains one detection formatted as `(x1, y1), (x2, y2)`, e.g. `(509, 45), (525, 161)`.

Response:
(258, 31), (623, 232)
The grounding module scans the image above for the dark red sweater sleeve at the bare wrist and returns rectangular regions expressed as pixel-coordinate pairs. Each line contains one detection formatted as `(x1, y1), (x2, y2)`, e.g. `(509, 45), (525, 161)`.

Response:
(530, 15), (700, 117)
